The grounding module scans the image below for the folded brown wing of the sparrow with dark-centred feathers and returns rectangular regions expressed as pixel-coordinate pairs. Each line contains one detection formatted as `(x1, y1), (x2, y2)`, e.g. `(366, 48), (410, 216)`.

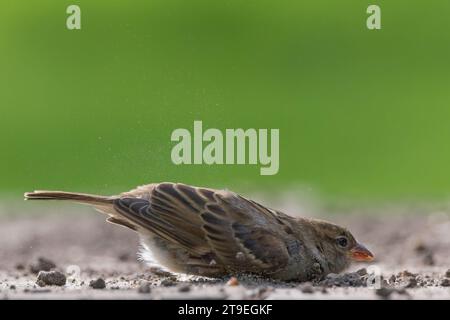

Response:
(114, 183), (290, 272)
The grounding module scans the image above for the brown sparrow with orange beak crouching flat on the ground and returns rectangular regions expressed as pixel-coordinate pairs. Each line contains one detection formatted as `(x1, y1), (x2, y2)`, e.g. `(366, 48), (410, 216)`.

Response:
(24, 182), (374, 282)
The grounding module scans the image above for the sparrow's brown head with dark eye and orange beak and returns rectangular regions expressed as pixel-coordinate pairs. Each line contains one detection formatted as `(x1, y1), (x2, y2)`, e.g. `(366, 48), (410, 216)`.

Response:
(311, 220), (374, 272)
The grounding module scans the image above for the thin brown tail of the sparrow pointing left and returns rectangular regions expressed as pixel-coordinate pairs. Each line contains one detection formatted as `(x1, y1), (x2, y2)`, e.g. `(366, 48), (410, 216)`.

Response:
(24, 190), (115, 205)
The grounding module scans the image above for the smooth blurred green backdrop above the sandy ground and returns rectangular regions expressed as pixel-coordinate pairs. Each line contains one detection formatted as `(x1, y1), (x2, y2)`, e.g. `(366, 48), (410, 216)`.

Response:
(0, 0), (450, 199)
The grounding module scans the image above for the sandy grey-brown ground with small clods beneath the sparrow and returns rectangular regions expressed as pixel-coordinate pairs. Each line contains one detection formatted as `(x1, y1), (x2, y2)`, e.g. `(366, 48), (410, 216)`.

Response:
(0, 205), (450, 299)
